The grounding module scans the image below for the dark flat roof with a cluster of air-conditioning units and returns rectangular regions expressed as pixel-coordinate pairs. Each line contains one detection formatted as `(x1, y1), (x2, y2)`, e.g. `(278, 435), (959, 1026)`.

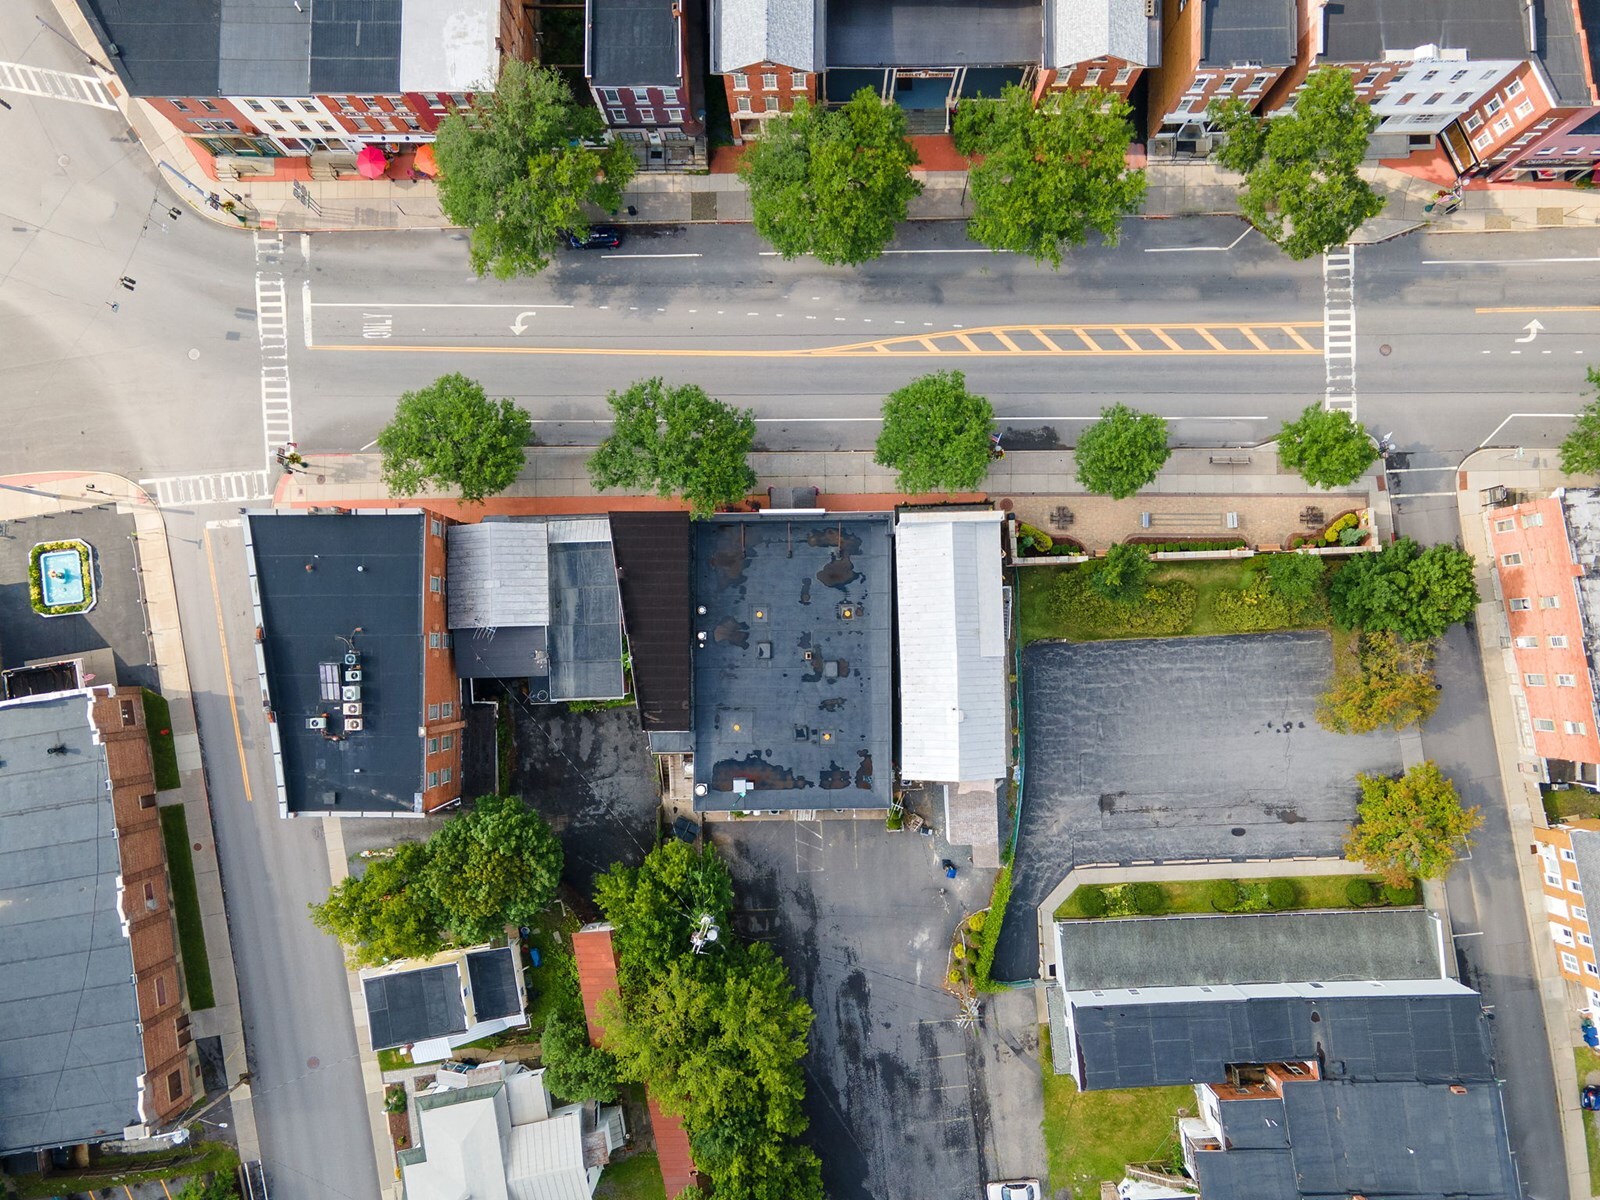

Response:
(248, 510), (427, 814)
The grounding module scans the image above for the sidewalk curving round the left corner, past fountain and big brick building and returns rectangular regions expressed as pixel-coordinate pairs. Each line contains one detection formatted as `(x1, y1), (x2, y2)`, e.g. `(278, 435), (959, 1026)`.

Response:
(0, 472), (261, 1162)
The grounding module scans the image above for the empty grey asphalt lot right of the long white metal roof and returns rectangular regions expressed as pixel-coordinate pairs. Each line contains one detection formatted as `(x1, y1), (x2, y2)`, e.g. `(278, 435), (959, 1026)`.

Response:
(995, 632), (1400, 979)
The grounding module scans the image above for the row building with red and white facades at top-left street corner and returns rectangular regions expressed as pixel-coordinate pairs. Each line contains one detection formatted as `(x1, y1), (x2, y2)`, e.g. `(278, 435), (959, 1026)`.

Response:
(78, 0), (518, 168)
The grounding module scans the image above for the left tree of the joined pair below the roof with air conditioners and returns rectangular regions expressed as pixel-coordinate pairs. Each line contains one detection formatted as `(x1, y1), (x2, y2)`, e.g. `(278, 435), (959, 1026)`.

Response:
(307, 842), (445, 966)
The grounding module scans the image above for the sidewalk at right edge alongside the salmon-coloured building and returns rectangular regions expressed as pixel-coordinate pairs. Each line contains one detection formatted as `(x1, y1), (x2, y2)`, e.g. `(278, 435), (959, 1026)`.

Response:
(1456, 448), (1590, 1197)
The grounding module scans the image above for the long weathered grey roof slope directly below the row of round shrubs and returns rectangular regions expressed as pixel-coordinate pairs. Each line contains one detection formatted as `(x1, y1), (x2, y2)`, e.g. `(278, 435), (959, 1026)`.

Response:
(1058, 909), (1443, 992)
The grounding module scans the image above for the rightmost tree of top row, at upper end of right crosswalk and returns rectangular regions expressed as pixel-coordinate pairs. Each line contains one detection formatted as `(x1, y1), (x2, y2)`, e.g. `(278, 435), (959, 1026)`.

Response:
(1206, 67), (1384, 259)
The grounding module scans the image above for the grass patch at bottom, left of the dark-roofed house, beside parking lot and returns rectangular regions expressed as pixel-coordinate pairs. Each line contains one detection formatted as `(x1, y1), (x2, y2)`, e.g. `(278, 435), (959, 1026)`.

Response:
(1038, 1029), (1195, 1200)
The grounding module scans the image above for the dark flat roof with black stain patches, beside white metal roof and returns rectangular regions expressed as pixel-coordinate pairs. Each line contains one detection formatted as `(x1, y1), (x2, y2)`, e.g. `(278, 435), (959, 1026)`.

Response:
(694, 514), (894, 810)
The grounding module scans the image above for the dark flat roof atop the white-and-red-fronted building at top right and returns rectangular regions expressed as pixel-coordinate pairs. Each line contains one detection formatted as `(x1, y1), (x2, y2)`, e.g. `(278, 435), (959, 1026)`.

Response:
(1322, 0), (1528, 62)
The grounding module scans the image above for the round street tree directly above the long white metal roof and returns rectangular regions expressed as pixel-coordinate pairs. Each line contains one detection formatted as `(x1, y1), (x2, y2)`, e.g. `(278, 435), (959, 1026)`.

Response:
(872, 371), (995, 493)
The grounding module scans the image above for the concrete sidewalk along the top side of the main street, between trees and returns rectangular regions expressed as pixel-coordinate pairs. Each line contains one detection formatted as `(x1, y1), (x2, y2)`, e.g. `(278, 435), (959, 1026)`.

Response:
(51, 0), (1600, 245)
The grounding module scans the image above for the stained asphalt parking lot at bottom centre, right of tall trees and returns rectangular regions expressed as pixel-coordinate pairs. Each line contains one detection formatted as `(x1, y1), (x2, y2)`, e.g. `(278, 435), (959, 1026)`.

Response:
(709, 819), (1043, 1200)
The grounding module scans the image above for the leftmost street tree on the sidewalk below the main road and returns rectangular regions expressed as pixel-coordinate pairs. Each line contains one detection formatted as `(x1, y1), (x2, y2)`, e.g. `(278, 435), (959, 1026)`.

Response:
(378, 374), (533, 502)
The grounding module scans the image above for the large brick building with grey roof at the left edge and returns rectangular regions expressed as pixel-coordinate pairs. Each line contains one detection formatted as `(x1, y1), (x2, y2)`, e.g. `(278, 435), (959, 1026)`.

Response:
(0, 685), (198, 1154)
